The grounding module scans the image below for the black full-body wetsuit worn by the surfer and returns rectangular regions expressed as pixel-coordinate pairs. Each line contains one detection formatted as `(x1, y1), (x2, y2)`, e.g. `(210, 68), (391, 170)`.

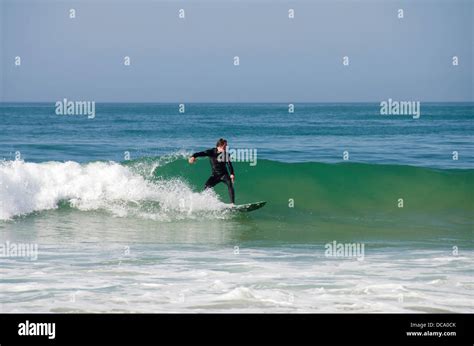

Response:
(193, 148), (235, 203)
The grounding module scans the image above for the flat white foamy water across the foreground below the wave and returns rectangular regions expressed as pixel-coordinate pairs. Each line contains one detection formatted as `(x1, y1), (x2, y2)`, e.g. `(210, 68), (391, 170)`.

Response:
(0, 243), (474, 313)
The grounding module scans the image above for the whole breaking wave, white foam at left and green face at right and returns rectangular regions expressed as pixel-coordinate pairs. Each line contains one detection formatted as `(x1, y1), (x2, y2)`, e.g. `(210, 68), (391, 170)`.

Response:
(0, 152), (474, 226)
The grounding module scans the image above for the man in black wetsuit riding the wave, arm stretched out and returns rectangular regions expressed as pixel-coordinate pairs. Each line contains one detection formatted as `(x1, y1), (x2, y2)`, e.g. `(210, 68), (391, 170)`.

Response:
(188, 138), (235, 204)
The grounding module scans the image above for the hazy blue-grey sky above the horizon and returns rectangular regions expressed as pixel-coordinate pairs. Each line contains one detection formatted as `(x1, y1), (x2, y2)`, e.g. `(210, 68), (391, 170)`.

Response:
(0, 0), (474, 102)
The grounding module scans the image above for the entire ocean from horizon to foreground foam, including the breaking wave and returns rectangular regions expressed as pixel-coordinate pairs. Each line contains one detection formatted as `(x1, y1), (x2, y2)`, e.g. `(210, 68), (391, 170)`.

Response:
(0, 103), (474, 313)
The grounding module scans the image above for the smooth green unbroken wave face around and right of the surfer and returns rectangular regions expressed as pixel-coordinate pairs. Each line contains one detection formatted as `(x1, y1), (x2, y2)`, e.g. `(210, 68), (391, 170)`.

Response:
(153, 159), (474, 215)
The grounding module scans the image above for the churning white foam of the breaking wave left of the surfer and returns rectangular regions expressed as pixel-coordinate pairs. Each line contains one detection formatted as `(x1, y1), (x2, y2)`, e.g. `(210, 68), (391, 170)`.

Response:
(0, 161), (224, 220)
